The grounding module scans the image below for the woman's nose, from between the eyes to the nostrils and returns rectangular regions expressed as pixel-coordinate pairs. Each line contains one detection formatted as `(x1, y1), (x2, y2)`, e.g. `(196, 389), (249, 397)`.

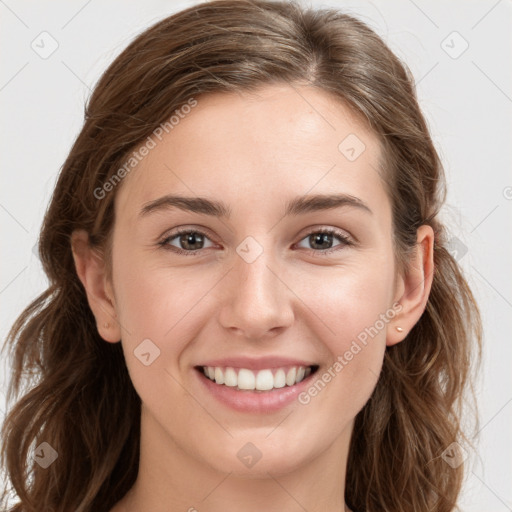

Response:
(220, 246), (294, 340)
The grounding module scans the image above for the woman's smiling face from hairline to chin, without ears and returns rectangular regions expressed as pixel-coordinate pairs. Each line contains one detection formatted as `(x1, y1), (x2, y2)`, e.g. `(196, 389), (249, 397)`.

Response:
(107, 85), (397, 475)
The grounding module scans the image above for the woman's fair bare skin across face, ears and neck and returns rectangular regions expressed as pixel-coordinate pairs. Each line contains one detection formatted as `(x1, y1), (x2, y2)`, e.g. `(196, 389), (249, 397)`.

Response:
(72, 85), (434, 512)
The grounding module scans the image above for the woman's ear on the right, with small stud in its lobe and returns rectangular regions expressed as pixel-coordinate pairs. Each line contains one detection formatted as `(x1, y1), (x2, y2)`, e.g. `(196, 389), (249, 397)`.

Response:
(386, 225), (434, 346)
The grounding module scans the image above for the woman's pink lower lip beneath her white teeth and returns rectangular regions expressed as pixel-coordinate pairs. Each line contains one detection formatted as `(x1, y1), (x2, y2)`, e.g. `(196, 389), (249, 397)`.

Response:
(194, 369), (318, 413)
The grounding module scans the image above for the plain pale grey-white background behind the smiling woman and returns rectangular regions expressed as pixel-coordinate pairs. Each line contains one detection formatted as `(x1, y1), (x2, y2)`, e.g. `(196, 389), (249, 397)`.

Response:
(0, 0), (512, 512)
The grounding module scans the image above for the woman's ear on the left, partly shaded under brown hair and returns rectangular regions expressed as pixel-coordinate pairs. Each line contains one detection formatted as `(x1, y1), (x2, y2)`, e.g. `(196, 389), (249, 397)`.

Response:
(71, 229), (121, 343)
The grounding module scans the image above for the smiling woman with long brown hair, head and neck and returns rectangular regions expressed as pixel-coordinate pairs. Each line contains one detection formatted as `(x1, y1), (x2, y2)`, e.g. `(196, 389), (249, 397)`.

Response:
(3, 0), (481, 512)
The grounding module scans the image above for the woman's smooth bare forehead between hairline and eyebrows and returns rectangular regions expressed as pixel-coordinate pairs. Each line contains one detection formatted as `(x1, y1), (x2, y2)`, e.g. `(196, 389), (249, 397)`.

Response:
(116, 85), (385, 221)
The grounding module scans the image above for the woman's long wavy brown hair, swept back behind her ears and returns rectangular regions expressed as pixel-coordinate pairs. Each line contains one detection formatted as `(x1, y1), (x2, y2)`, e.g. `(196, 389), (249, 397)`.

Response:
(2, 0), (481, 512)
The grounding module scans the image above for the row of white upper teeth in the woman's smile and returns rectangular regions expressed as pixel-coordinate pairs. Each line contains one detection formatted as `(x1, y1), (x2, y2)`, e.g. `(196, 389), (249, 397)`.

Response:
(203, 366), (311, 391)
